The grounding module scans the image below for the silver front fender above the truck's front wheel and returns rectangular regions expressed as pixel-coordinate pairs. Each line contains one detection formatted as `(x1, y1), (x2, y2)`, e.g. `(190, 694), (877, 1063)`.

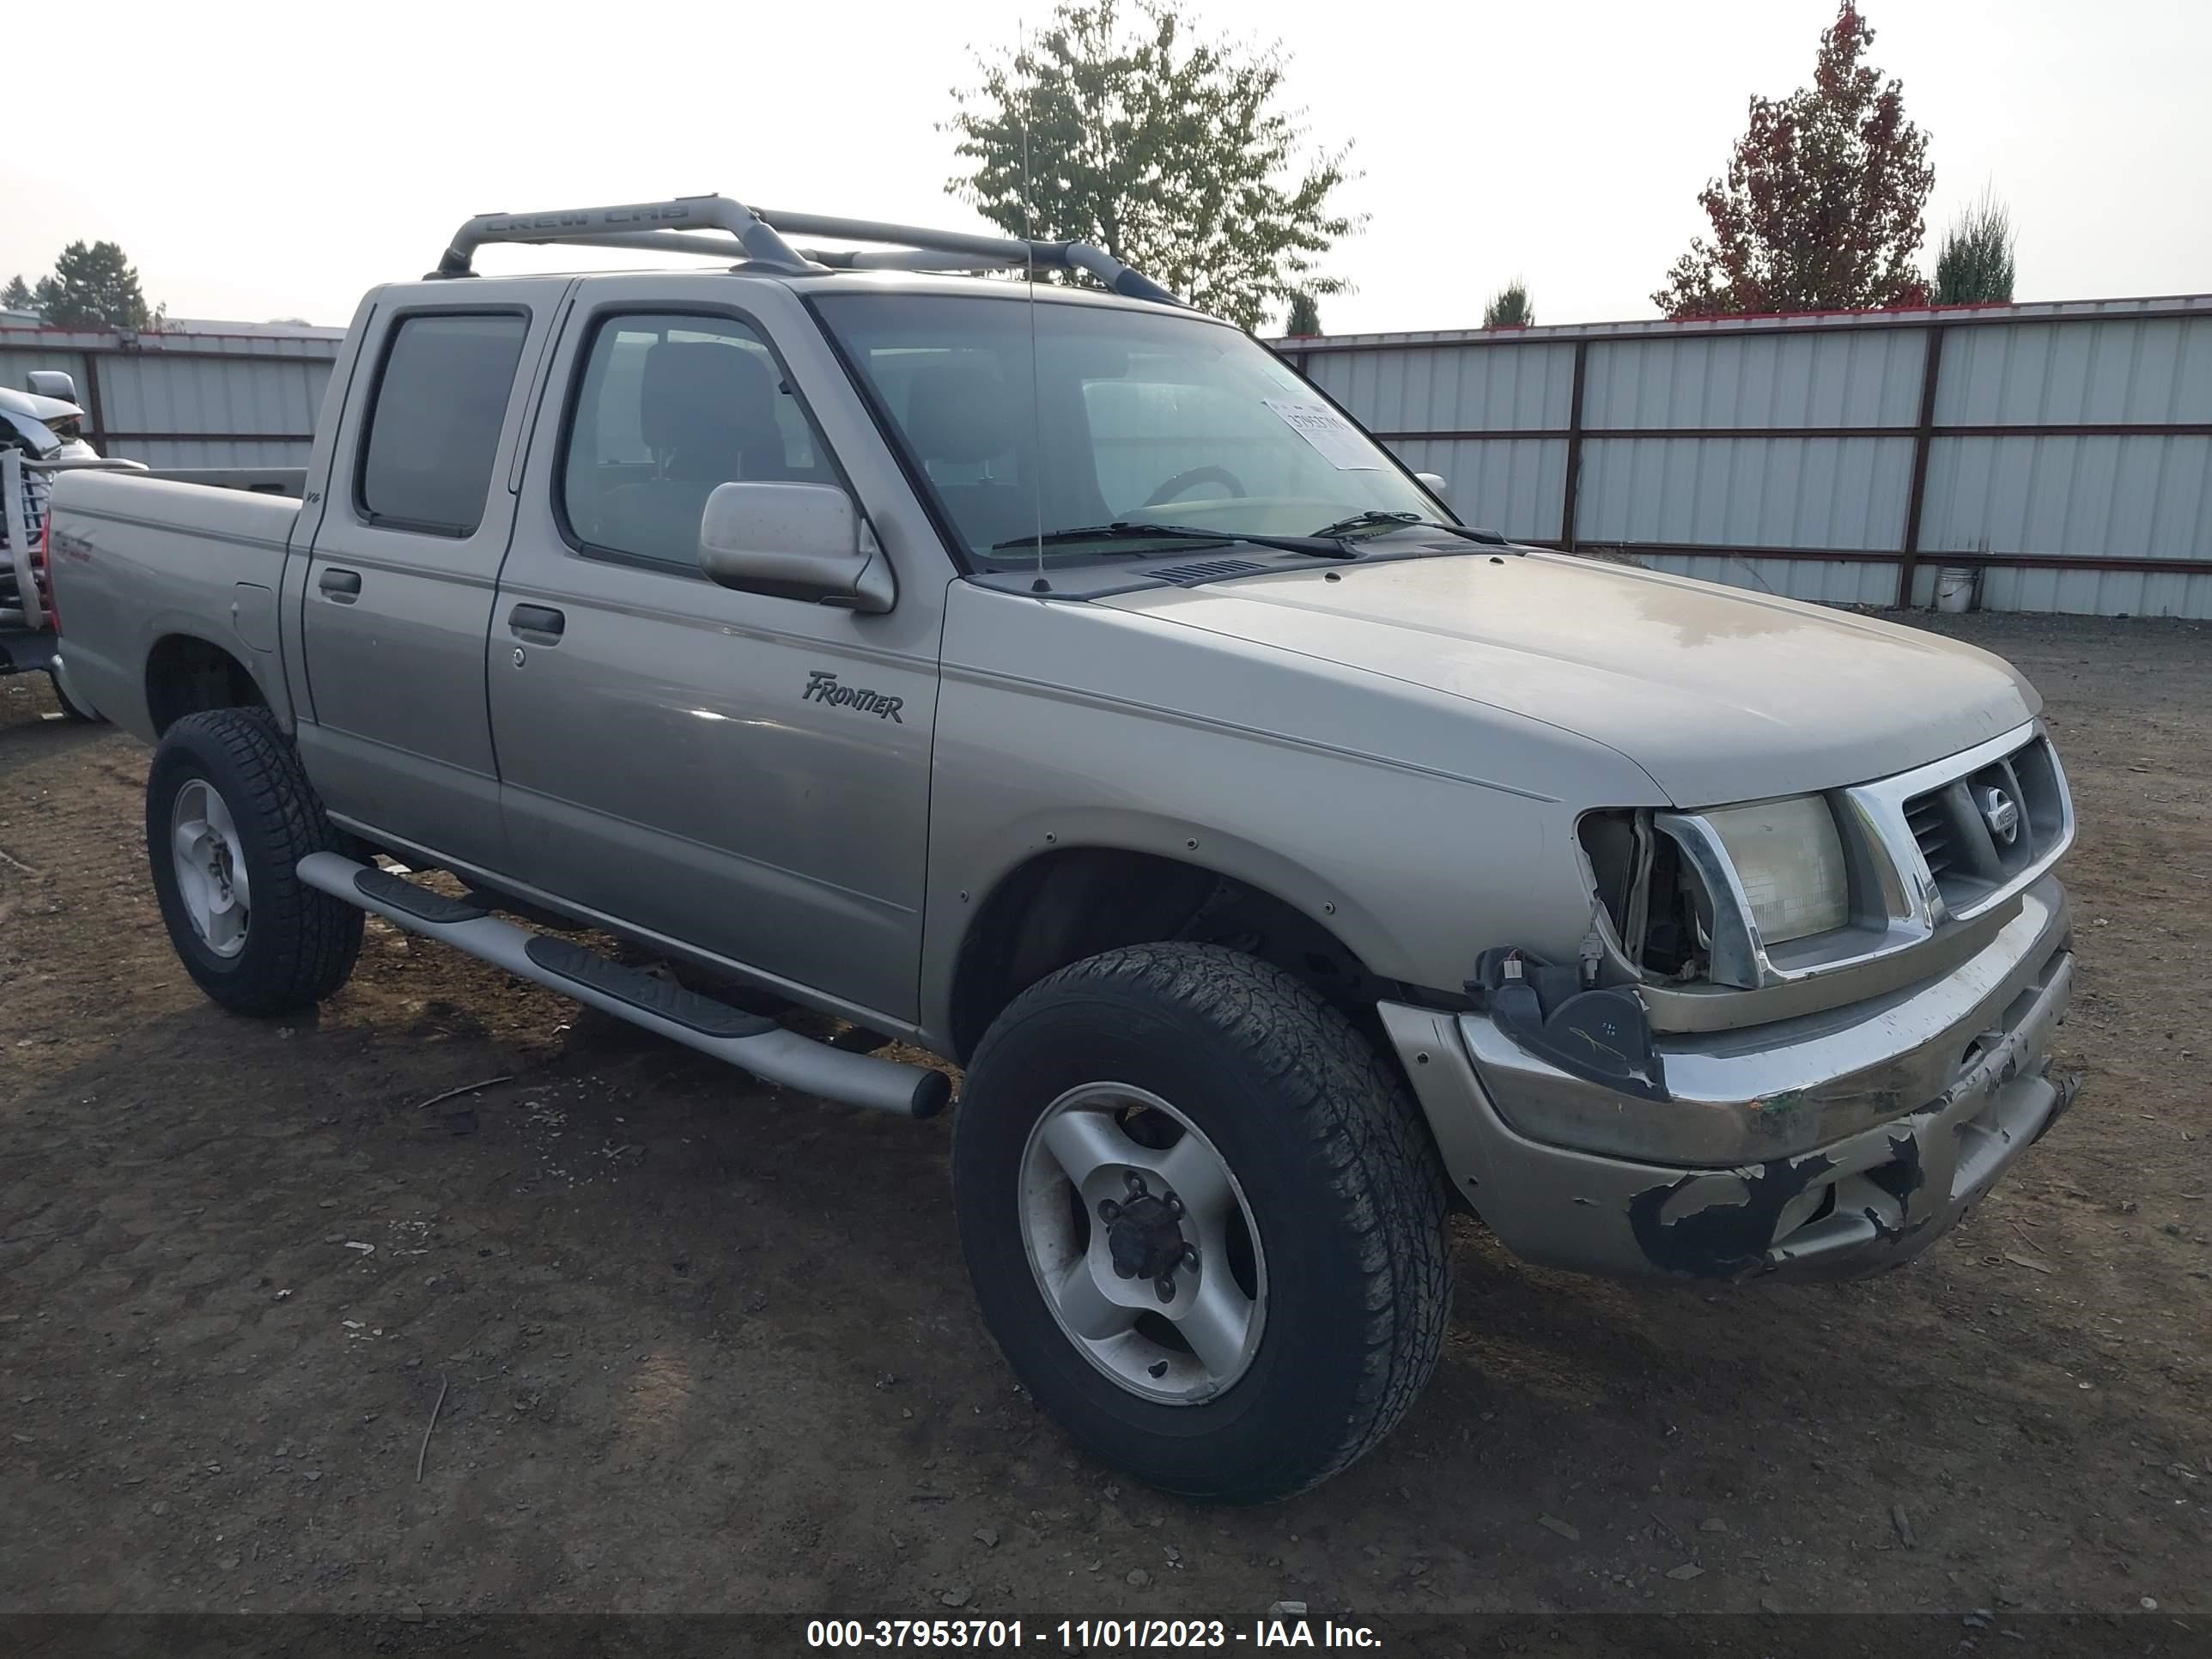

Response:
(918, 601), (1652, 1042)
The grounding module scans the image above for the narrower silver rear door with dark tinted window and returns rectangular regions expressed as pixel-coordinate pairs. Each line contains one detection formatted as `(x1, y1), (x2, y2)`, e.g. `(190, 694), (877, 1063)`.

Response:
(299, 292), (564, 869)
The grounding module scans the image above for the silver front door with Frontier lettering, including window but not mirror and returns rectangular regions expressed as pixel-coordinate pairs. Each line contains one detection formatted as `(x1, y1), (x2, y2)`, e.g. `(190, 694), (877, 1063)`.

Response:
(487, 274), (951, 1020)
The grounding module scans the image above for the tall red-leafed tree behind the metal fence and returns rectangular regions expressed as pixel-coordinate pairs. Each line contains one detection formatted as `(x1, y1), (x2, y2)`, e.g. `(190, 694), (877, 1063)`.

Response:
(1652, 0), (1936, 316)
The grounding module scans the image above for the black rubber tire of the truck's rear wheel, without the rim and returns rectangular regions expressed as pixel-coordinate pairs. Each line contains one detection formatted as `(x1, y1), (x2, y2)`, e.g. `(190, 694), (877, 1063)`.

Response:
(146, 708), (362, 1018)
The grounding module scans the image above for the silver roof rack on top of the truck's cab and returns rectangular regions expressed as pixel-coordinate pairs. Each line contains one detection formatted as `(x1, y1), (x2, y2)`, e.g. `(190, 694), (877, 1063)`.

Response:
(429, 197), (1183, 305)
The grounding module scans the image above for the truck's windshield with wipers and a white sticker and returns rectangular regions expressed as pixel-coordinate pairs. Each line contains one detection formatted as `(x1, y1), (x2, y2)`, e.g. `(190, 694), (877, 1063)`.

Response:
(817, 289), (1437, 568)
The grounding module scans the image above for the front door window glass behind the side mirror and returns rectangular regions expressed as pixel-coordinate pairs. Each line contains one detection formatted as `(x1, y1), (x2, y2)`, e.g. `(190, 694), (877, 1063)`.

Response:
(557, 314), (838, 568)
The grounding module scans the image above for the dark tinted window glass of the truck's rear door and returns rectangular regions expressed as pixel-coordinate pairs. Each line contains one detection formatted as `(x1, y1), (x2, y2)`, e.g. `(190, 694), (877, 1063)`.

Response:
(361, 312), (529, 535)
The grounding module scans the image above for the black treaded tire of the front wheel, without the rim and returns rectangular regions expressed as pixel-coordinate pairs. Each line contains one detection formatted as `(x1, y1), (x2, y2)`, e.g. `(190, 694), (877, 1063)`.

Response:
(953, 945), (1451, 1502)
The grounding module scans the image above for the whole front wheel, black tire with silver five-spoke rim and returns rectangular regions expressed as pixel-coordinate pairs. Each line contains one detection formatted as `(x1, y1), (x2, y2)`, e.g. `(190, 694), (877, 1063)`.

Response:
(953, 945), (1451, 1502)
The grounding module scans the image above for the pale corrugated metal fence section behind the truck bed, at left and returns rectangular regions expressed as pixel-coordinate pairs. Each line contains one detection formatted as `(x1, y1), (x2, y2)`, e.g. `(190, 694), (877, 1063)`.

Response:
(0, 323), (345, 467)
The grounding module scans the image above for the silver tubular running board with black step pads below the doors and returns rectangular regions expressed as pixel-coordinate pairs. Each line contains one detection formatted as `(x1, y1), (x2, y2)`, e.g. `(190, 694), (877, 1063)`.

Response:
(299, 852), (951, 1117)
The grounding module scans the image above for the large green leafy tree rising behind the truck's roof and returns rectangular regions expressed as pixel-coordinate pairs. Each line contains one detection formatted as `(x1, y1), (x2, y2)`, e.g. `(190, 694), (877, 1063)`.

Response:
(945, 0), (1358, 330)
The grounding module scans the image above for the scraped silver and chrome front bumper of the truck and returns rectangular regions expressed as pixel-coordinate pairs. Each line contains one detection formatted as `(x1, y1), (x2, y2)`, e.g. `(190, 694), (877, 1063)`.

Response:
(1382, 876), (2073, 1279)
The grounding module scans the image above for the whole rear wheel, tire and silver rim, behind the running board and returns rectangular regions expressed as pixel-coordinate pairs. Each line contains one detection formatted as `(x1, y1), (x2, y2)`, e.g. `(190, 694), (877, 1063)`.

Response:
(146, 708), (361, 1015)
